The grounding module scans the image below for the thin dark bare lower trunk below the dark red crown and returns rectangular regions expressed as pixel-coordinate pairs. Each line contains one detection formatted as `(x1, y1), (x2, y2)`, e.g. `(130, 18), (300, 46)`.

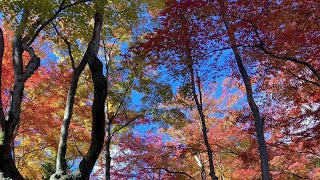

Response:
(189, 64), (218, 180)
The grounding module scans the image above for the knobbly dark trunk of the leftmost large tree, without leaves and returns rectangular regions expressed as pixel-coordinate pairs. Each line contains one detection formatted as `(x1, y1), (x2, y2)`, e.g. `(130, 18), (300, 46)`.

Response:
(0, 24), (40, 179)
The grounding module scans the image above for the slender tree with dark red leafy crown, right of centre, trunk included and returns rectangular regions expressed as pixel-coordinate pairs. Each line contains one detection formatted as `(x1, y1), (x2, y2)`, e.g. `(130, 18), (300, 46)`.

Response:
(131, 1), (221, 179)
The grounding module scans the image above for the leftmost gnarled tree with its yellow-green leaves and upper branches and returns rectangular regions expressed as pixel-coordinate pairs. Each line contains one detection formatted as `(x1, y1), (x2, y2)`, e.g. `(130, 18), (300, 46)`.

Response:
(0, 1), (90, 179)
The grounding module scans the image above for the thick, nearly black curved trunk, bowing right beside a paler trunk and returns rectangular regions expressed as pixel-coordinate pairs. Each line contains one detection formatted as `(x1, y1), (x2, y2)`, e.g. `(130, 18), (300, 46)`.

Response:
(51, 0), (107, 179)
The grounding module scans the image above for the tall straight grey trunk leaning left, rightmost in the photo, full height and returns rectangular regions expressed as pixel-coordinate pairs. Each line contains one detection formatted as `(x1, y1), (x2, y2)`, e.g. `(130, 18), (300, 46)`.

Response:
(219, 0), (270, 180)
